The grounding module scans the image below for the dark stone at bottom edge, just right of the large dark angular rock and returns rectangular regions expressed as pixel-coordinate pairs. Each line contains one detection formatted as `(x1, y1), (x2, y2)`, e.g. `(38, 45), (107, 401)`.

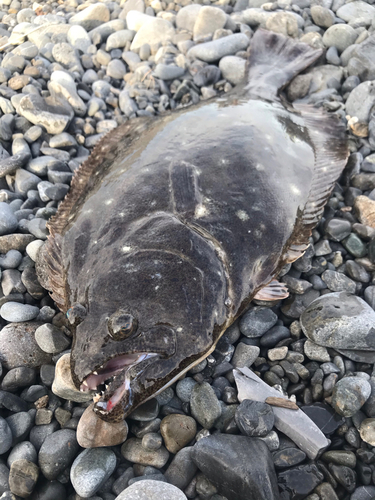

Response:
(277, 464), (324, 500)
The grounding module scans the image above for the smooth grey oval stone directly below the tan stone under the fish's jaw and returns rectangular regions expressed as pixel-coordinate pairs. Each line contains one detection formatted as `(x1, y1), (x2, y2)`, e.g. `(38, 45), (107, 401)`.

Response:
(70, 448), (116, 498)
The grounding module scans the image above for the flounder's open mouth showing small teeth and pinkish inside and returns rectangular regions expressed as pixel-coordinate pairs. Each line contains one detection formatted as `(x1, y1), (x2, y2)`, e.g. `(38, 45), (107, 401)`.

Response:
(80, 352), (158, 417)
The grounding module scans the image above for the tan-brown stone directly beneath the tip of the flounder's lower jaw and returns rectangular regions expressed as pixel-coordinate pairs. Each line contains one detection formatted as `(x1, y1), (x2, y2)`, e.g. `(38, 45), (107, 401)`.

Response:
(77, 403), (128, 448)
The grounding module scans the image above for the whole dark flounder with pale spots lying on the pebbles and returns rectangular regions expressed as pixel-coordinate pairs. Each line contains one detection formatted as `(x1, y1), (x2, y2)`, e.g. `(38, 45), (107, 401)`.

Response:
(38, 30), (348, 422)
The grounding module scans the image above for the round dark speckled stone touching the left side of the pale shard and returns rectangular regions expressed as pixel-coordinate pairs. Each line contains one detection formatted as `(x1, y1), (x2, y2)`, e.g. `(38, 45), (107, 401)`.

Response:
(235, 399), (275, 437)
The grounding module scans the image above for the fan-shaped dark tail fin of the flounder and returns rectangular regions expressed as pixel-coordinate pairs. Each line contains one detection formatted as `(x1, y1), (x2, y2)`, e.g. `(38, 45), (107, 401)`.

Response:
(246, 29), (323, 100)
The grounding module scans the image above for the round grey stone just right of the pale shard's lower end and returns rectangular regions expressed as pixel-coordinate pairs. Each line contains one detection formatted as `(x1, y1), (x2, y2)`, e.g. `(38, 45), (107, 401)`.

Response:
(332, 377), (371, 417)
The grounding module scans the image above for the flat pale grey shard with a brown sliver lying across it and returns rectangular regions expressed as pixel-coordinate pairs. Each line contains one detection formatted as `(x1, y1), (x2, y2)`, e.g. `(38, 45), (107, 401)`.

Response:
(233, 368), (330, 460)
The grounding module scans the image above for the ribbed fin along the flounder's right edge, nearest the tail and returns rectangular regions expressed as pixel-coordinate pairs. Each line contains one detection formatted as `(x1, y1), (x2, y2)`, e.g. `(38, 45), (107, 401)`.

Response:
(281, 104), (349, 265)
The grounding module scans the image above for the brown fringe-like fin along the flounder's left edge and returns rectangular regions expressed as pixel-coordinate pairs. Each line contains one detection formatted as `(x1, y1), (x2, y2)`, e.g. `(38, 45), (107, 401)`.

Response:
(43, 117), (154, 312)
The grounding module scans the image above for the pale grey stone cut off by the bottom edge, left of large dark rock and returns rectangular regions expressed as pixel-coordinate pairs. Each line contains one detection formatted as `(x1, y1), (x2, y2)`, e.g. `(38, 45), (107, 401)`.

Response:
(115, 479), (187, 500)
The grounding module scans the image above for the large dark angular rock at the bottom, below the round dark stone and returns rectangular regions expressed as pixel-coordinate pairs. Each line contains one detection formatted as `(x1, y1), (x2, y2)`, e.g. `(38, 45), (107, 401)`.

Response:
(192, 434), (279, 500)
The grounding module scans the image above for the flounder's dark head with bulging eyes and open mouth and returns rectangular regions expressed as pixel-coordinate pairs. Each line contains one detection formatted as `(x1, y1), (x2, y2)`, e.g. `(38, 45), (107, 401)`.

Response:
(67, 246), (226, 422)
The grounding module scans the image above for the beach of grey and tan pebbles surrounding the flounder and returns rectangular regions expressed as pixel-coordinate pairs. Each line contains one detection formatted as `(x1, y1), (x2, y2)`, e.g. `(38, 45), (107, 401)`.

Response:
(0, 0), (375, 500)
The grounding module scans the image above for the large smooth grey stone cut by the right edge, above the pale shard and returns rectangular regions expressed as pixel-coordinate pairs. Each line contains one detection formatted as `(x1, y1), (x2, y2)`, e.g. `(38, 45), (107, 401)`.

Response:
(301, 292), (375, 350)
